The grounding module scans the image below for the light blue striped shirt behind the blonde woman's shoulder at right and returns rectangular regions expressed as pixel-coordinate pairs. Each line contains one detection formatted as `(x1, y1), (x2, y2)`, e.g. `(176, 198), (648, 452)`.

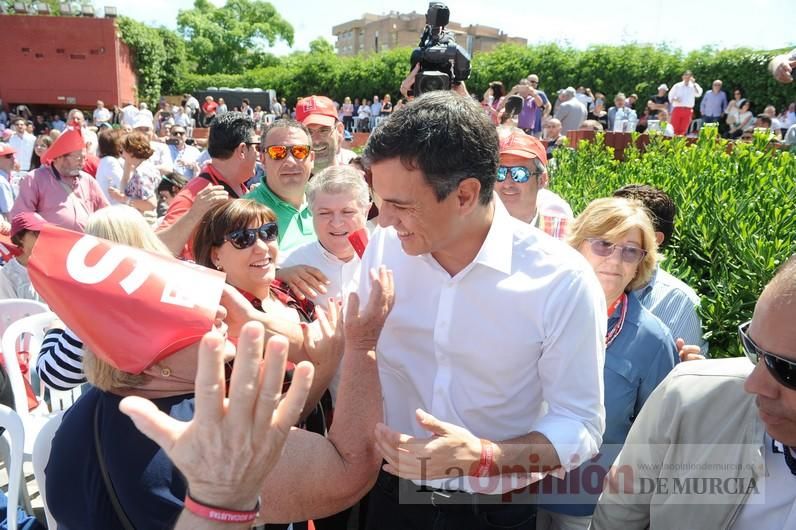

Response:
(633, 266), (708, 356)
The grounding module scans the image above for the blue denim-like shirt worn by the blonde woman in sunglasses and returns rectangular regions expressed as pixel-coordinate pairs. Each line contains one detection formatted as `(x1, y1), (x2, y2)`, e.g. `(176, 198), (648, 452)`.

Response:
(539, 295), (680, 517)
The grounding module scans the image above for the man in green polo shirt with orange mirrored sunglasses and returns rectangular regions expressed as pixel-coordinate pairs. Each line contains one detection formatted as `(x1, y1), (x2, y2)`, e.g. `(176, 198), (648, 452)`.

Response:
(246, 120), (317, 255)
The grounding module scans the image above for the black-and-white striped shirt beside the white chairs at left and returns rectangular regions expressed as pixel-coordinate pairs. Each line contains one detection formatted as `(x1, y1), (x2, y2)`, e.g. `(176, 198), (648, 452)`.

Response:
(36, 328), (86, 390)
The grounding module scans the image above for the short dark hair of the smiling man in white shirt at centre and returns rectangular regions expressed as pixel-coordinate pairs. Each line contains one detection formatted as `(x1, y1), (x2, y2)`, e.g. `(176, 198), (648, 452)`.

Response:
(365, 90), (499, 205)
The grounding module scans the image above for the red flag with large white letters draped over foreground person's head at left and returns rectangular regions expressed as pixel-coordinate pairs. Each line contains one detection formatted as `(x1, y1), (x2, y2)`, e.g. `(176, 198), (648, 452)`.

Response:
(28, 225), (224, 374)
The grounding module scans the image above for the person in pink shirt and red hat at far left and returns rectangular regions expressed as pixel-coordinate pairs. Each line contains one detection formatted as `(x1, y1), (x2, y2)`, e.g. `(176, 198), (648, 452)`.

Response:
(11, 130), (108, 232)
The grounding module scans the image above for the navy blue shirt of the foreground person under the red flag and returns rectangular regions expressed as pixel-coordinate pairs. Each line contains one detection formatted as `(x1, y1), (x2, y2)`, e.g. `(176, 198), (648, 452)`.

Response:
(45, 388), (194, 530)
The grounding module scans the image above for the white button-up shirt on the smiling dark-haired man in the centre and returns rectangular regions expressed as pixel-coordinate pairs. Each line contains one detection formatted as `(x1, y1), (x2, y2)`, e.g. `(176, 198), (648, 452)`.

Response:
(359, 197), (606, 493)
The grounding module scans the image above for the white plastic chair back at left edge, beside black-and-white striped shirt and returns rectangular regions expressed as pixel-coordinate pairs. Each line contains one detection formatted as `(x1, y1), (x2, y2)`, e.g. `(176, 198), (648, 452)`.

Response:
(2, 311), (56, 420)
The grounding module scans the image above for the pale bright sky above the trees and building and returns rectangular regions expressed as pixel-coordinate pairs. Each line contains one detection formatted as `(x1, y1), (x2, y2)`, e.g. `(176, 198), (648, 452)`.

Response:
(115, 0), (796, 55)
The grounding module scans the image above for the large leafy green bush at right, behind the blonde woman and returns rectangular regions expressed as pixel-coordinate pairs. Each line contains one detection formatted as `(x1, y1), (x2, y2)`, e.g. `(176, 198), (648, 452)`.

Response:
(551, 127), (796, 357)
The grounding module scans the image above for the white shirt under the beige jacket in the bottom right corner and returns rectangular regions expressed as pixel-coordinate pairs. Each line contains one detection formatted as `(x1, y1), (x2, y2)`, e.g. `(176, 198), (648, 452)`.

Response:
(732, 434), (796, 530)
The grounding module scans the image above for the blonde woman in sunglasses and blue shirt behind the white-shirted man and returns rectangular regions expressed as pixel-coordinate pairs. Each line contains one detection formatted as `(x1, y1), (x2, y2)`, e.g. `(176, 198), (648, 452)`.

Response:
(537, 198), (679, 530)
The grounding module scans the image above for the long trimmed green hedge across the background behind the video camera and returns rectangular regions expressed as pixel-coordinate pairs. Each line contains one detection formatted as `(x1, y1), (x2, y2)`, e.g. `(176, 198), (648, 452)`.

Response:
(175, 44), (794, 112)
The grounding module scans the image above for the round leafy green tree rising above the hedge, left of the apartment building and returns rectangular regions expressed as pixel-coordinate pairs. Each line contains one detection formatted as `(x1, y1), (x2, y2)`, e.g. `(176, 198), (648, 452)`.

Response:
(177, 0), (293, 74)
